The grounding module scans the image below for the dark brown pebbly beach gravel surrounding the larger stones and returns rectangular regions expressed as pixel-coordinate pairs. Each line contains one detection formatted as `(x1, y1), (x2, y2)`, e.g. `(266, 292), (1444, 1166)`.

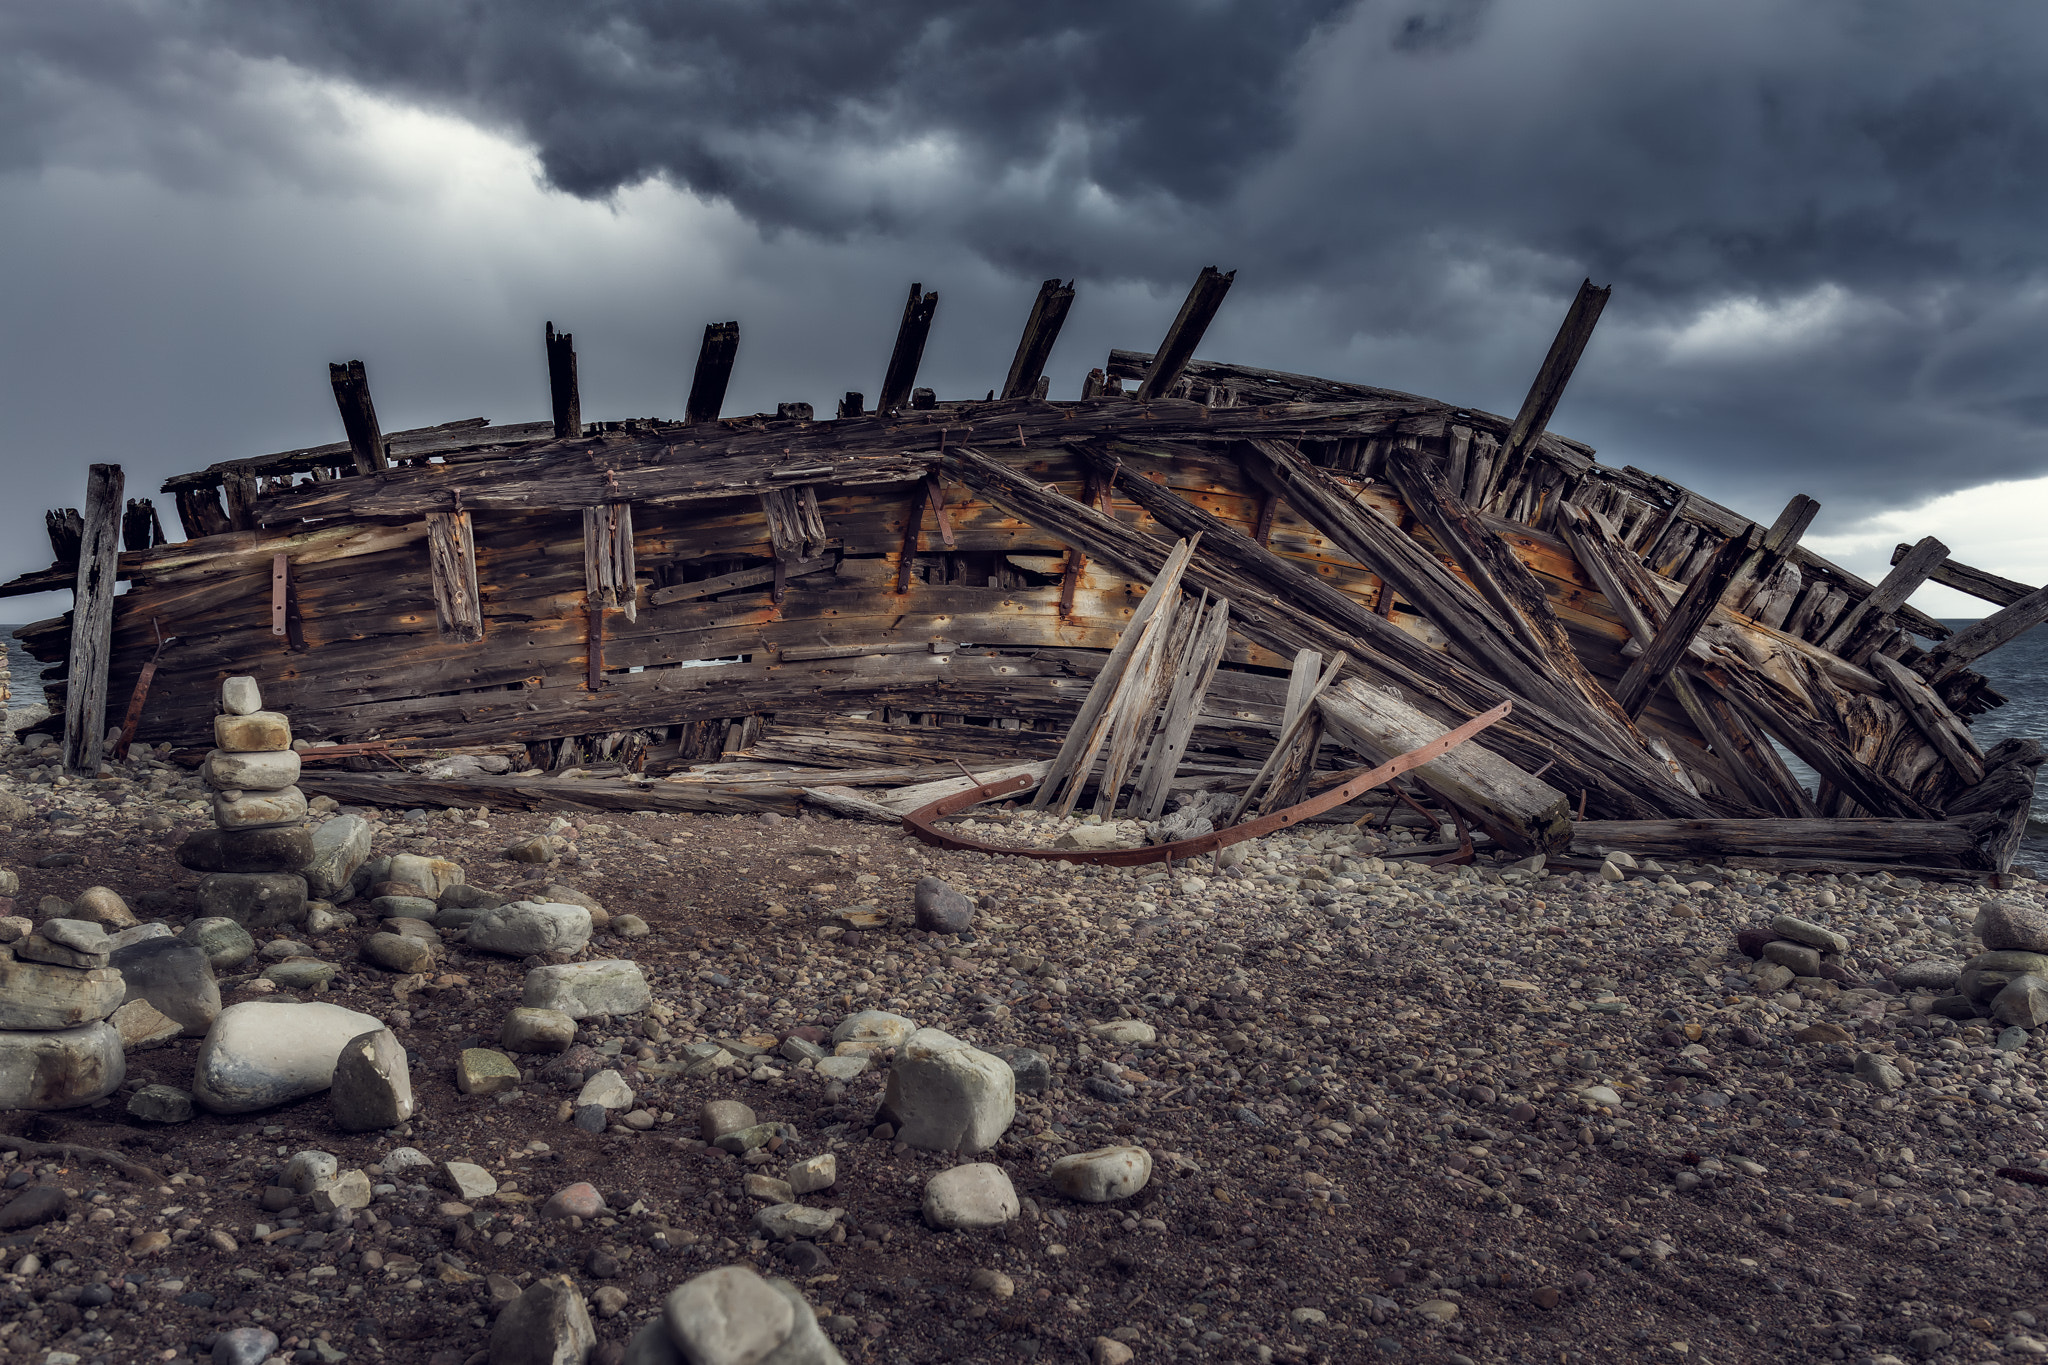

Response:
(0, 736), (2048, 1365)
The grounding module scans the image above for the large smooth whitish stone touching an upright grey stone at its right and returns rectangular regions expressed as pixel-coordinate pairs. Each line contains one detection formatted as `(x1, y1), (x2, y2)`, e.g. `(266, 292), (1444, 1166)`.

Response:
(193, 998), (383, 1113)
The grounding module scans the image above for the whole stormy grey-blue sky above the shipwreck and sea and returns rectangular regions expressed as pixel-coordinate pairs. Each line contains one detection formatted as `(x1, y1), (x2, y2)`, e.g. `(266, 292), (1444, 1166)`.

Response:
(0, 0), (2048, 620)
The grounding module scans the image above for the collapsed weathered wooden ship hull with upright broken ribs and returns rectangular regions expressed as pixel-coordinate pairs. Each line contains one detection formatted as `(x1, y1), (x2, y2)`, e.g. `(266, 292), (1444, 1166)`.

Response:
(0, 272), (2048, 876)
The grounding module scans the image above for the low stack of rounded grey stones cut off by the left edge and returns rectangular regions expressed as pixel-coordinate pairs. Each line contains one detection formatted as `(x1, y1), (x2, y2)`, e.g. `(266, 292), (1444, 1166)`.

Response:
(0, 915), (127, 1109)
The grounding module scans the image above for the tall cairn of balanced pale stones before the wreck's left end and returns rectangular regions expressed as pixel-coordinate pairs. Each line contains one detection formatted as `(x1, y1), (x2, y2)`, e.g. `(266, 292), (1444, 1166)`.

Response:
(191, 677), (313, 929)
